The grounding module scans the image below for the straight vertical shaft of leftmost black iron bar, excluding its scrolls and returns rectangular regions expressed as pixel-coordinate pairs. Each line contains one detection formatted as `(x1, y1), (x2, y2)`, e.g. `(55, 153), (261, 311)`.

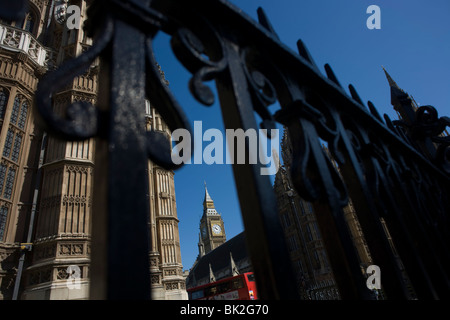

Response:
(92, 17), (151, 299)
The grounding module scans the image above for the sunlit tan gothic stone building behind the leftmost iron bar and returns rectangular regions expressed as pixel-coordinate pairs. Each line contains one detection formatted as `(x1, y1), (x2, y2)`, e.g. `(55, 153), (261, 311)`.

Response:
(0, 0), (187, 299)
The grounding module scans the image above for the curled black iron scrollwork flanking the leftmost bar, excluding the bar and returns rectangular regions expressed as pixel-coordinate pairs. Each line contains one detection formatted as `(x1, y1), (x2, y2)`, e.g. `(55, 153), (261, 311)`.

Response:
(36, 1), (193, 169)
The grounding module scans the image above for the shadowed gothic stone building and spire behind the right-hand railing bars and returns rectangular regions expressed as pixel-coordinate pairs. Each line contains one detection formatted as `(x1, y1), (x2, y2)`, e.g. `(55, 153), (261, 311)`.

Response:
(274, 68), (417, 300)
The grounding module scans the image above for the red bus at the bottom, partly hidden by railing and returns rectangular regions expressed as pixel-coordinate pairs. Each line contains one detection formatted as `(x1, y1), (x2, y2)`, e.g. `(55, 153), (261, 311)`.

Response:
(187, 272), (258, 300)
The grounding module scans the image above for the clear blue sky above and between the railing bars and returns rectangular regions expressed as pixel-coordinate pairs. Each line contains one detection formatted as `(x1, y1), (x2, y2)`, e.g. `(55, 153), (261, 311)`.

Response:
(155, 0), (450, 269)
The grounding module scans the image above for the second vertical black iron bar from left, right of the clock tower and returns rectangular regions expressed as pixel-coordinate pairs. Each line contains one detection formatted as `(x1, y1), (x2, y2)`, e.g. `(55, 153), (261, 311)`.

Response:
(216, 40), (299, 299)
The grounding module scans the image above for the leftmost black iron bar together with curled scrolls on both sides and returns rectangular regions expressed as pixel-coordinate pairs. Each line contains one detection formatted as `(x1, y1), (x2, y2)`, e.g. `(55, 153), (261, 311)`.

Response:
(31, 0), (190, 299)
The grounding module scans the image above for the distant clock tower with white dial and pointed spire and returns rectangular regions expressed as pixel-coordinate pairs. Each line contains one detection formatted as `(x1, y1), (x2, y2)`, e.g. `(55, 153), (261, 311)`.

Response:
(199, 183), (226, 257)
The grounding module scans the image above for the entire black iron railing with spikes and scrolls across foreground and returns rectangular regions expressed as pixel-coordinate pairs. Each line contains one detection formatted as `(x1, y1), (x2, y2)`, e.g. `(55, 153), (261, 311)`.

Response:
(1, 0), (450, 299)
